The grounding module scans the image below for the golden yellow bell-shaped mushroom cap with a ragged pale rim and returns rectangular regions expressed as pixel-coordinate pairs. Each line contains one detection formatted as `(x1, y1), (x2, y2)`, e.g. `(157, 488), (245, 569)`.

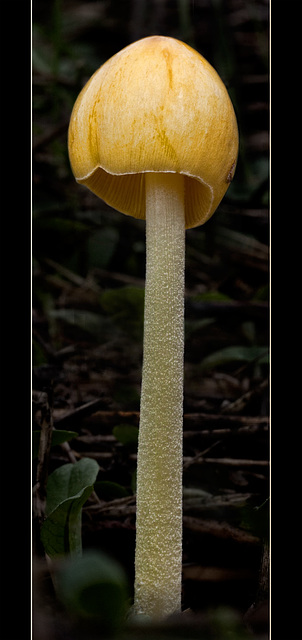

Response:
(68, 36), (238, 228)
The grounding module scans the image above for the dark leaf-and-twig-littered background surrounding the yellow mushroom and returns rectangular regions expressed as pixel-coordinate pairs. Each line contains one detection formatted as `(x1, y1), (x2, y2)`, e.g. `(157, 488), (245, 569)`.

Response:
(32, 0), (270, 640)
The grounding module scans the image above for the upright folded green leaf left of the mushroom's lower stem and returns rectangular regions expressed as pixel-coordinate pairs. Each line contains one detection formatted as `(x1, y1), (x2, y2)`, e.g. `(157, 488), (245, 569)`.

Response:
(41, 458), (99, 557)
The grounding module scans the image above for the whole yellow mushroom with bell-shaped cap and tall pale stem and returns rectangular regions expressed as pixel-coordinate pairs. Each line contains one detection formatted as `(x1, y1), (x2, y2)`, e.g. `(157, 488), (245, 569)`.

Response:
(68, 36), (238, 619)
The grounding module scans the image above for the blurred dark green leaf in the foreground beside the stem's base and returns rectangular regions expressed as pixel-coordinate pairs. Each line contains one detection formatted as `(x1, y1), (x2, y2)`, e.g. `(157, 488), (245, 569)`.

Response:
(56, 551), (128, 629)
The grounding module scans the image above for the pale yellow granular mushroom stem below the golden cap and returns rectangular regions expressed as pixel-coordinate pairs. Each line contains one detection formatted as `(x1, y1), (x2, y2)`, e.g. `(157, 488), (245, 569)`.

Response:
(134, 173), (185, 619)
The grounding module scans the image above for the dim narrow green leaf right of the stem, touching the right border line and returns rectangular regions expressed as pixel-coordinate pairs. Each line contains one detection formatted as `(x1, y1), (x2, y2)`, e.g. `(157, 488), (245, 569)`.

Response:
(200, 345), (268, 371)
